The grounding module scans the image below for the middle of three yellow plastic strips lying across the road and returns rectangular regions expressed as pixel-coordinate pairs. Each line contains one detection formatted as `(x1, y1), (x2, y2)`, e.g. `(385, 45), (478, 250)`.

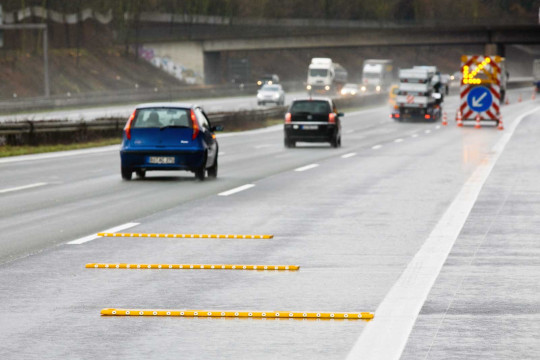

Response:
(86, 263), (300, 270)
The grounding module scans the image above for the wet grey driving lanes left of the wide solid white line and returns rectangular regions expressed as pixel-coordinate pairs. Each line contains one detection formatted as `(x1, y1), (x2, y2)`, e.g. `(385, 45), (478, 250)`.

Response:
(0, 91), (534, 359)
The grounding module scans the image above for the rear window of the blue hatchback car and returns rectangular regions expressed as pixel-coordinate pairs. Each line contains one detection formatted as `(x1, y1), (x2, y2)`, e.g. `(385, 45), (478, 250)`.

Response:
(132, 108), (192, 128)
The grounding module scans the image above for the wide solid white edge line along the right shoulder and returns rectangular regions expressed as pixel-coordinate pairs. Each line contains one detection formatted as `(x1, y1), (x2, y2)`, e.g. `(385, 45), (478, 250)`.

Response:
(347, 107), (540, 360)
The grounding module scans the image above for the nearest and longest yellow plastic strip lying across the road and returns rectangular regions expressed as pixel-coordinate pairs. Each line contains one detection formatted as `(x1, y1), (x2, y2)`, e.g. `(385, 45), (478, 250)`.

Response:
(101, 309), (374, 320)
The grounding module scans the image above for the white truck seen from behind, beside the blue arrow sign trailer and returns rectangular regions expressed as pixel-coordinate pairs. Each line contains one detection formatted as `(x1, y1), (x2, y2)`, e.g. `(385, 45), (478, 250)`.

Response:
(391, 67), (442, 121)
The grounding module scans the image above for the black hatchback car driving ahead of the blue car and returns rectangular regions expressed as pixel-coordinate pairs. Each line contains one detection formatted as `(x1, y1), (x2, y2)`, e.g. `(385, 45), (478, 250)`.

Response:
(284, 98), (343, 148)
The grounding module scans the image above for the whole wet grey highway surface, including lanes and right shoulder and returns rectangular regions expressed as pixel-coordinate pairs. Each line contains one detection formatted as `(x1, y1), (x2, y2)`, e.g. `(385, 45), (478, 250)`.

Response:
(0, 88), (540, 359)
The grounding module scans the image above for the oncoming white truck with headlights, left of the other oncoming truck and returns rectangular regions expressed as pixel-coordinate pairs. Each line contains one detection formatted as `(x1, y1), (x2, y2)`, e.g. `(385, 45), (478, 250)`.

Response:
(306, 58), (347, 93)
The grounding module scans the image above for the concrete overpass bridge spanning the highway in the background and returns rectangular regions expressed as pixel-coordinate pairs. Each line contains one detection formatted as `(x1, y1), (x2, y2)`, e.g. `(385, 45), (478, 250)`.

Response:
(144, 25), (540, 84)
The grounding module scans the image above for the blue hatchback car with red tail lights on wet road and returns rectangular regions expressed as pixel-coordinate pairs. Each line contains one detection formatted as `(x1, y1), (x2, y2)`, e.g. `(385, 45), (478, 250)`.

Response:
(120, 103), (221, 180)
